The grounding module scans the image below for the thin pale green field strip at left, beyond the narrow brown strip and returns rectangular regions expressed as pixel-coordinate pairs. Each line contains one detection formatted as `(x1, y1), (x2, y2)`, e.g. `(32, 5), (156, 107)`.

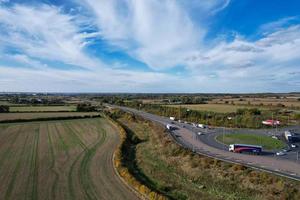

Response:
(9, 106), (76, 112)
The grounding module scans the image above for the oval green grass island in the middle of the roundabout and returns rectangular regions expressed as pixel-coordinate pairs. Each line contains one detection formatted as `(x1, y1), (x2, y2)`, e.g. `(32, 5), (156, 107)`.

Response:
(216, 133), (285, 150)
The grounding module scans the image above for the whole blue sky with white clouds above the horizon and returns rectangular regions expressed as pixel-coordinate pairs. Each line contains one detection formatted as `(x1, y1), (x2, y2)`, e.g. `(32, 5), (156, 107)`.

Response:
(0, 0), (300, 93)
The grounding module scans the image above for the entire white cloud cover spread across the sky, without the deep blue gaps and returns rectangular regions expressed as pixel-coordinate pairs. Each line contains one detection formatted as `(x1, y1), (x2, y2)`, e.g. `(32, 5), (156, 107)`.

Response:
(0, 0), (300, 92)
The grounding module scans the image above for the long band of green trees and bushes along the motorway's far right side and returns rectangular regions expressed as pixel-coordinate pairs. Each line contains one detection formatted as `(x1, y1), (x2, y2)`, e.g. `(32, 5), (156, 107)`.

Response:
(119, 101), (285, 128)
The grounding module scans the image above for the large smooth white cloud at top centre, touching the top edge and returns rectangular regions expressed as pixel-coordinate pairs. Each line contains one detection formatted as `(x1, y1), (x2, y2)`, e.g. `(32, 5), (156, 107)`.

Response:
(81, 0), (205, 69)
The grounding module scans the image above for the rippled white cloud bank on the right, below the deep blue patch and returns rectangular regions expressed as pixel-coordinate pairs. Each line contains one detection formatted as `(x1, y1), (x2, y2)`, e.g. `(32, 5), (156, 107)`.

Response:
(186, 25), (300, 89)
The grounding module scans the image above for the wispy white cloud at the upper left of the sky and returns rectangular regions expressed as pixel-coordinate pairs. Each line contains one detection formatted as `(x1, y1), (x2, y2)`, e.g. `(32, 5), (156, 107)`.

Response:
(0, 4), (99, 68)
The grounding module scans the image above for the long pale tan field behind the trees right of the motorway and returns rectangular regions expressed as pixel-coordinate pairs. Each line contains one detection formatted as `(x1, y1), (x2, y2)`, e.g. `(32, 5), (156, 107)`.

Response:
(167, 104), (268, 113)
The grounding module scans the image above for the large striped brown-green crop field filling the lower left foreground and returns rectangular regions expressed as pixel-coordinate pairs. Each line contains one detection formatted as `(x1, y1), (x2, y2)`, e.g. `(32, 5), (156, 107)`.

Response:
(0, 118), (136, 200)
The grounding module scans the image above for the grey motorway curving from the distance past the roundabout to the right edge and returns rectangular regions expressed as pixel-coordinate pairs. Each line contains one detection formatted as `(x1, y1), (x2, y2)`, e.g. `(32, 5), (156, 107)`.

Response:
(110, 105), (300, 181)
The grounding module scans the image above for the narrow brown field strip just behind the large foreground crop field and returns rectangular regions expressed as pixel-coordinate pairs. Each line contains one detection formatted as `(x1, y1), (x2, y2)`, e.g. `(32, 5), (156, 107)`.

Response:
(0, 112), (99, 122)
